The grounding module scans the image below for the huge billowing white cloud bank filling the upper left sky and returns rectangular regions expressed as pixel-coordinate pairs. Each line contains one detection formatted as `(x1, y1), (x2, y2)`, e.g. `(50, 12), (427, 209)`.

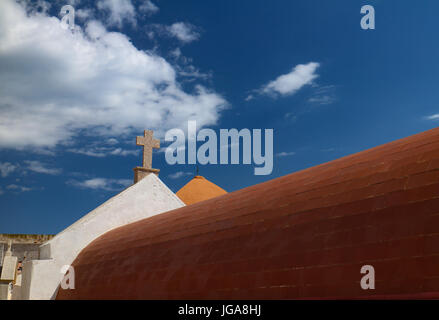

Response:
(0, 0), (227, 150)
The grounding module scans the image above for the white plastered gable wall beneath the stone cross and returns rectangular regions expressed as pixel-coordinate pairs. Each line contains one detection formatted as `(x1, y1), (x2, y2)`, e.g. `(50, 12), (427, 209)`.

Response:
(20, 174), (185, 300)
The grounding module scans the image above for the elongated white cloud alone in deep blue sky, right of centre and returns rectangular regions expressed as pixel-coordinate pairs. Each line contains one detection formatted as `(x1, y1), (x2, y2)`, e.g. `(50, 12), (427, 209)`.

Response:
(258, 62), (319, 100)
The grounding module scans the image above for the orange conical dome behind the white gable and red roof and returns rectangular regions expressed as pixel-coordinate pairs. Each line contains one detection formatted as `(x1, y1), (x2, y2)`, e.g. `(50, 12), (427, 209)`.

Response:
(177, 176), (227, 205)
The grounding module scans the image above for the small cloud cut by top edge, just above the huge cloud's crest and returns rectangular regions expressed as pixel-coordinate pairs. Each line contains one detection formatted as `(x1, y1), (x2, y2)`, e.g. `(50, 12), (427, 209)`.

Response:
(96, 0), (137, 28)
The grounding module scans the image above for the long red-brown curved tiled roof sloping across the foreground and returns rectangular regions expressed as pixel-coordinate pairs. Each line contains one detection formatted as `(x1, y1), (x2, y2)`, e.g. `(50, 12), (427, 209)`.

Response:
(57, 129), (439, 299)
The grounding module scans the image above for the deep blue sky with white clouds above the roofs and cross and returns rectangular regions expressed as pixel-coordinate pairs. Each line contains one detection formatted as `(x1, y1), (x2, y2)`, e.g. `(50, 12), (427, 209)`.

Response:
(0, 0), (439, 233)
